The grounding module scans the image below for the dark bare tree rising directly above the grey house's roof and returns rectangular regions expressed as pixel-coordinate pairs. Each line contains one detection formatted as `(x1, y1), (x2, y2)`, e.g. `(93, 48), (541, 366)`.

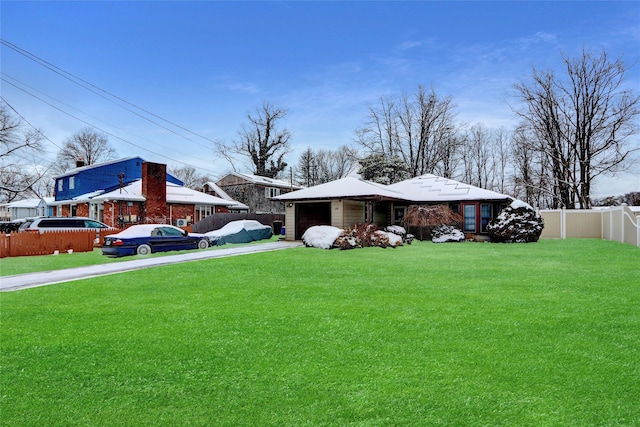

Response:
(216, 101), (291, 178)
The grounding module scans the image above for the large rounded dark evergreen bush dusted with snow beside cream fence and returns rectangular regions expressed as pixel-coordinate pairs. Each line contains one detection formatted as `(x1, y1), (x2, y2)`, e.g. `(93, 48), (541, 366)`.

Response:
(487, 200), (544, 243)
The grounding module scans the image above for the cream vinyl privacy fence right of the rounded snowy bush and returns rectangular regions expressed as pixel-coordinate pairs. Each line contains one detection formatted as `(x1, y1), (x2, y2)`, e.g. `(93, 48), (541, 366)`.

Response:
(540, 206), (640, 248)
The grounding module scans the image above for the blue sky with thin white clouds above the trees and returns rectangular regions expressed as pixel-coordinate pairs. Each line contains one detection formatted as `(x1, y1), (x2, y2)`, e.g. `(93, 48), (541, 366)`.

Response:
(0, 0), (640, 195)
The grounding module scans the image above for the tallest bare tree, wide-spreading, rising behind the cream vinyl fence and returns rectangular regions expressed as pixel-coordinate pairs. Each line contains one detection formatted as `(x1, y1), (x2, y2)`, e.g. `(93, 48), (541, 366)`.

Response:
(514, 50), (640, 208)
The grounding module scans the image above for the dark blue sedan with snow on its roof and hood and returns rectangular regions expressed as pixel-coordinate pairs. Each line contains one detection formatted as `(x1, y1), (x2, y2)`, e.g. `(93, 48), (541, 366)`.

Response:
(102, 224), (209, 257)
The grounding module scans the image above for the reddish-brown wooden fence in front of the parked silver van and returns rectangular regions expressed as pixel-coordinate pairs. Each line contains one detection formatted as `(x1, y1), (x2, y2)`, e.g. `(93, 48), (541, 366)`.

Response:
(0, 230), (118, 258)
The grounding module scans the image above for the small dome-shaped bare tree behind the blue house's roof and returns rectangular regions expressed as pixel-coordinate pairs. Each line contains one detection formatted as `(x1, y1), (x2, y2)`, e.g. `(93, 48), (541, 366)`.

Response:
(55, 127), (117, 173)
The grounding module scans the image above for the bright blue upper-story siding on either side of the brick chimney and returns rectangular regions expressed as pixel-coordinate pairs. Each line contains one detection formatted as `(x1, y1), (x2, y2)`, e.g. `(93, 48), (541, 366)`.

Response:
(54, 157), (184, 201)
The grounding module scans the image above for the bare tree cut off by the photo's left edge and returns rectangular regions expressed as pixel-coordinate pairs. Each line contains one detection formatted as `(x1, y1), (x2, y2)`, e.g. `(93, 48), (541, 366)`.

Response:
(0, 104), (46, 202)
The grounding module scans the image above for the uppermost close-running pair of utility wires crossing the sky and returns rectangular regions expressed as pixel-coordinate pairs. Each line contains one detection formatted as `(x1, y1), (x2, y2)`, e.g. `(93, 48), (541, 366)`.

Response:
(0, 38), (217, 148)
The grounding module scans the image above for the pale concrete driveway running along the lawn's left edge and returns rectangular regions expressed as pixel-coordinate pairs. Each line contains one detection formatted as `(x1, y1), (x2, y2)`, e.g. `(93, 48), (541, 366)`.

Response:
(0, 241), (302, 292)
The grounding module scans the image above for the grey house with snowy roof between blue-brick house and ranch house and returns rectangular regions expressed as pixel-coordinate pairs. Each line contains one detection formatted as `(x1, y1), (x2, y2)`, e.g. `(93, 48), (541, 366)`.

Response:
(216, 172), (303, 213)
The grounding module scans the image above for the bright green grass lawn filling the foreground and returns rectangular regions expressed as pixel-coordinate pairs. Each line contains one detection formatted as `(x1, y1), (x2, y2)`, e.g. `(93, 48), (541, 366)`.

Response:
(0, 240), (640, 426)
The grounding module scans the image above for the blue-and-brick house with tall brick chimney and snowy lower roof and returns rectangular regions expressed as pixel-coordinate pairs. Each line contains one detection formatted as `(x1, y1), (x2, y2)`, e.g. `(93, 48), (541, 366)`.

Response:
(51, 157), (238, 227)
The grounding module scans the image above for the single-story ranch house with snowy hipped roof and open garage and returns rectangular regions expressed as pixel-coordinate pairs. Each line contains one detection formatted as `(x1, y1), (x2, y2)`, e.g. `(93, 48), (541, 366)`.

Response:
(277, 174), (512, 240)
